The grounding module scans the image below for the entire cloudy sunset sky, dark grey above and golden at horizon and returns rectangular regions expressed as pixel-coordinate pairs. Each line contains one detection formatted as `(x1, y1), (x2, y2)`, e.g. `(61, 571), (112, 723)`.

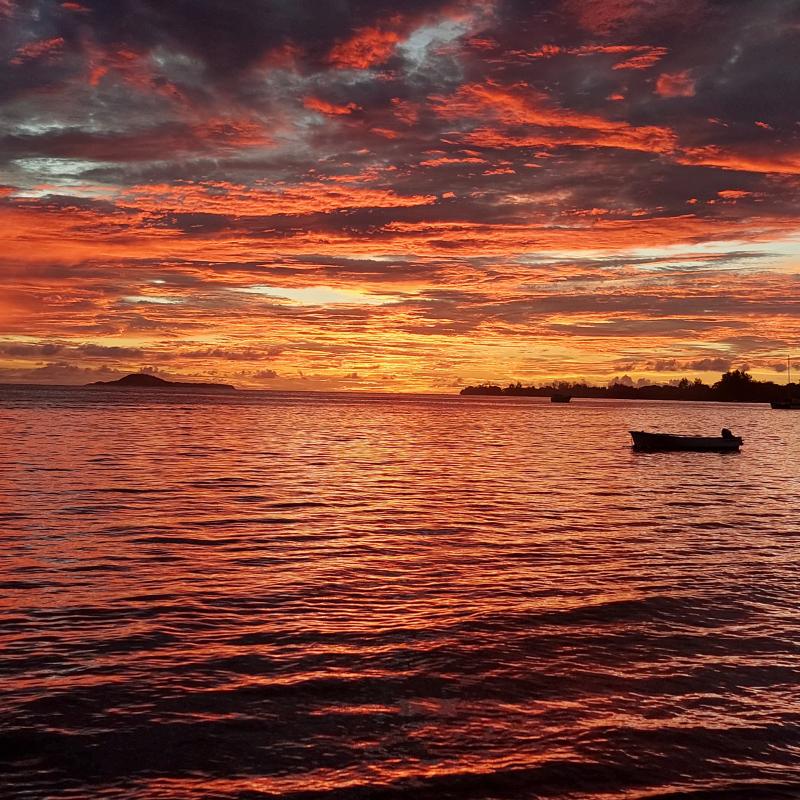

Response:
(0, 0), (800, 392)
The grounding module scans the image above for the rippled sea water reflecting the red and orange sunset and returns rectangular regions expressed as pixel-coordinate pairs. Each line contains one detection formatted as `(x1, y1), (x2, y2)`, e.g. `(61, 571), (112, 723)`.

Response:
(0, 387), (800, 800)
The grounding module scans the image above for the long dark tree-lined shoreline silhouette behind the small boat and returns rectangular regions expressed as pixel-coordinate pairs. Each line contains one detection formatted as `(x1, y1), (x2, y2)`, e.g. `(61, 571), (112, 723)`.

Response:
(459, 369), (800, 403)
